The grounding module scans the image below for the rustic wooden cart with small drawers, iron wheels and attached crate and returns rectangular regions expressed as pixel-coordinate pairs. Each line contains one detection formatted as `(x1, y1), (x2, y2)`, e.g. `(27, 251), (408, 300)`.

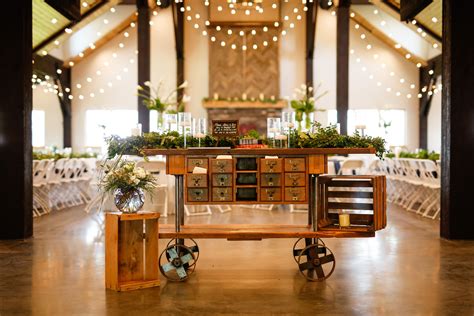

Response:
(145, 148), (386, 281)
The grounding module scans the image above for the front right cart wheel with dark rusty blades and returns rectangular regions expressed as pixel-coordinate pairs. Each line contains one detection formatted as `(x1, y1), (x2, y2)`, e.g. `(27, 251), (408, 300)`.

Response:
(298, 243), (336, 281)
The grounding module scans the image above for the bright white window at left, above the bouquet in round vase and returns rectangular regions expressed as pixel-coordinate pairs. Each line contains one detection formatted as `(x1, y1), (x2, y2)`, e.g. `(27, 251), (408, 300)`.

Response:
(85, 110), (138, 147)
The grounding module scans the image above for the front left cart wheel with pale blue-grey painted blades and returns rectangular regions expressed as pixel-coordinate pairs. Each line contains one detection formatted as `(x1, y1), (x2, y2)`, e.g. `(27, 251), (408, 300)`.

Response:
(158, 244), (196, 281)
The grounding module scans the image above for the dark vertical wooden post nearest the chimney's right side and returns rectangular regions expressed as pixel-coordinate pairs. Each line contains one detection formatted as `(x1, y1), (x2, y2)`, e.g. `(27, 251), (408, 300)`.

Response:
(306, 2), (319, 87)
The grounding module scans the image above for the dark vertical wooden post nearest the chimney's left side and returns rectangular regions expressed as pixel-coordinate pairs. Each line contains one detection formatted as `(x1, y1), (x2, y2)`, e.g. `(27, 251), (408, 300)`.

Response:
(172, 1), (184, 102)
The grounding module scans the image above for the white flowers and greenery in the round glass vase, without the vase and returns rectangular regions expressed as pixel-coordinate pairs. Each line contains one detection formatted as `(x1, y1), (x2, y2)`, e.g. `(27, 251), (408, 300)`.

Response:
(99, 160), (156, 193)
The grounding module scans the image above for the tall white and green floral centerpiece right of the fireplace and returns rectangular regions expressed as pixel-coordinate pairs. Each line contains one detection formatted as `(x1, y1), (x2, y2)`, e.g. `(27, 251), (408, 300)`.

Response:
(290, 84), (328, 132)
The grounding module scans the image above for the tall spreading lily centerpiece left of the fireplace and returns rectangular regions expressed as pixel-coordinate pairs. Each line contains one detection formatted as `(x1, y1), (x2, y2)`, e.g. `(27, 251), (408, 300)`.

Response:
(137, 81), (190, 129)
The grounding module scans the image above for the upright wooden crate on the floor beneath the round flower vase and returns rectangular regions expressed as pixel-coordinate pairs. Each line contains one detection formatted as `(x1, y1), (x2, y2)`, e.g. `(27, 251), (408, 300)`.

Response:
(105, 212), (160, 291)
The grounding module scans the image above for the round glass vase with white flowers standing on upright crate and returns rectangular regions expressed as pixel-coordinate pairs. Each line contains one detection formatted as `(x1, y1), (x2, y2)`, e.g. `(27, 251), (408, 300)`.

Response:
(100, 160), (156, 213)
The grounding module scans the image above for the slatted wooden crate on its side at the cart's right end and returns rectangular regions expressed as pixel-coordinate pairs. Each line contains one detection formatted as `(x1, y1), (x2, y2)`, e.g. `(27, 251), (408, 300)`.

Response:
(317, 175), (387, 232)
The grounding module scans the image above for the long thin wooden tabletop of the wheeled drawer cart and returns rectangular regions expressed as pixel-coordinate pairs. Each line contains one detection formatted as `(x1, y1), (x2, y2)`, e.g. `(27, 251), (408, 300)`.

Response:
(143, 147), (375, 156)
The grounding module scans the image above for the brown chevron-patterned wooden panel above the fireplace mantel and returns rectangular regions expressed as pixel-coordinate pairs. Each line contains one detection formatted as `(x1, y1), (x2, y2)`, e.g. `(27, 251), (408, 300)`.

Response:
(209, 27), (280, 98)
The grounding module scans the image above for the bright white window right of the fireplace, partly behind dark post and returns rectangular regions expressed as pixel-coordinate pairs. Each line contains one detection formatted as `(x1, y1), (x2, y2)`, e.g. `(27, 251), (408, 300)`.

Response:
(328, 109), (406, 146)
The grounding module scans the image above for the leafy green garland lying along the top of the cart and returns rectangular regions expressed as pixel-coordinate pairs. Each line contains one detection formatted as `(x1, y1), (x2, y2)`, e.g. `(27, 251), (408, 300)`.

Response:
(107, 124), (385, 158)
